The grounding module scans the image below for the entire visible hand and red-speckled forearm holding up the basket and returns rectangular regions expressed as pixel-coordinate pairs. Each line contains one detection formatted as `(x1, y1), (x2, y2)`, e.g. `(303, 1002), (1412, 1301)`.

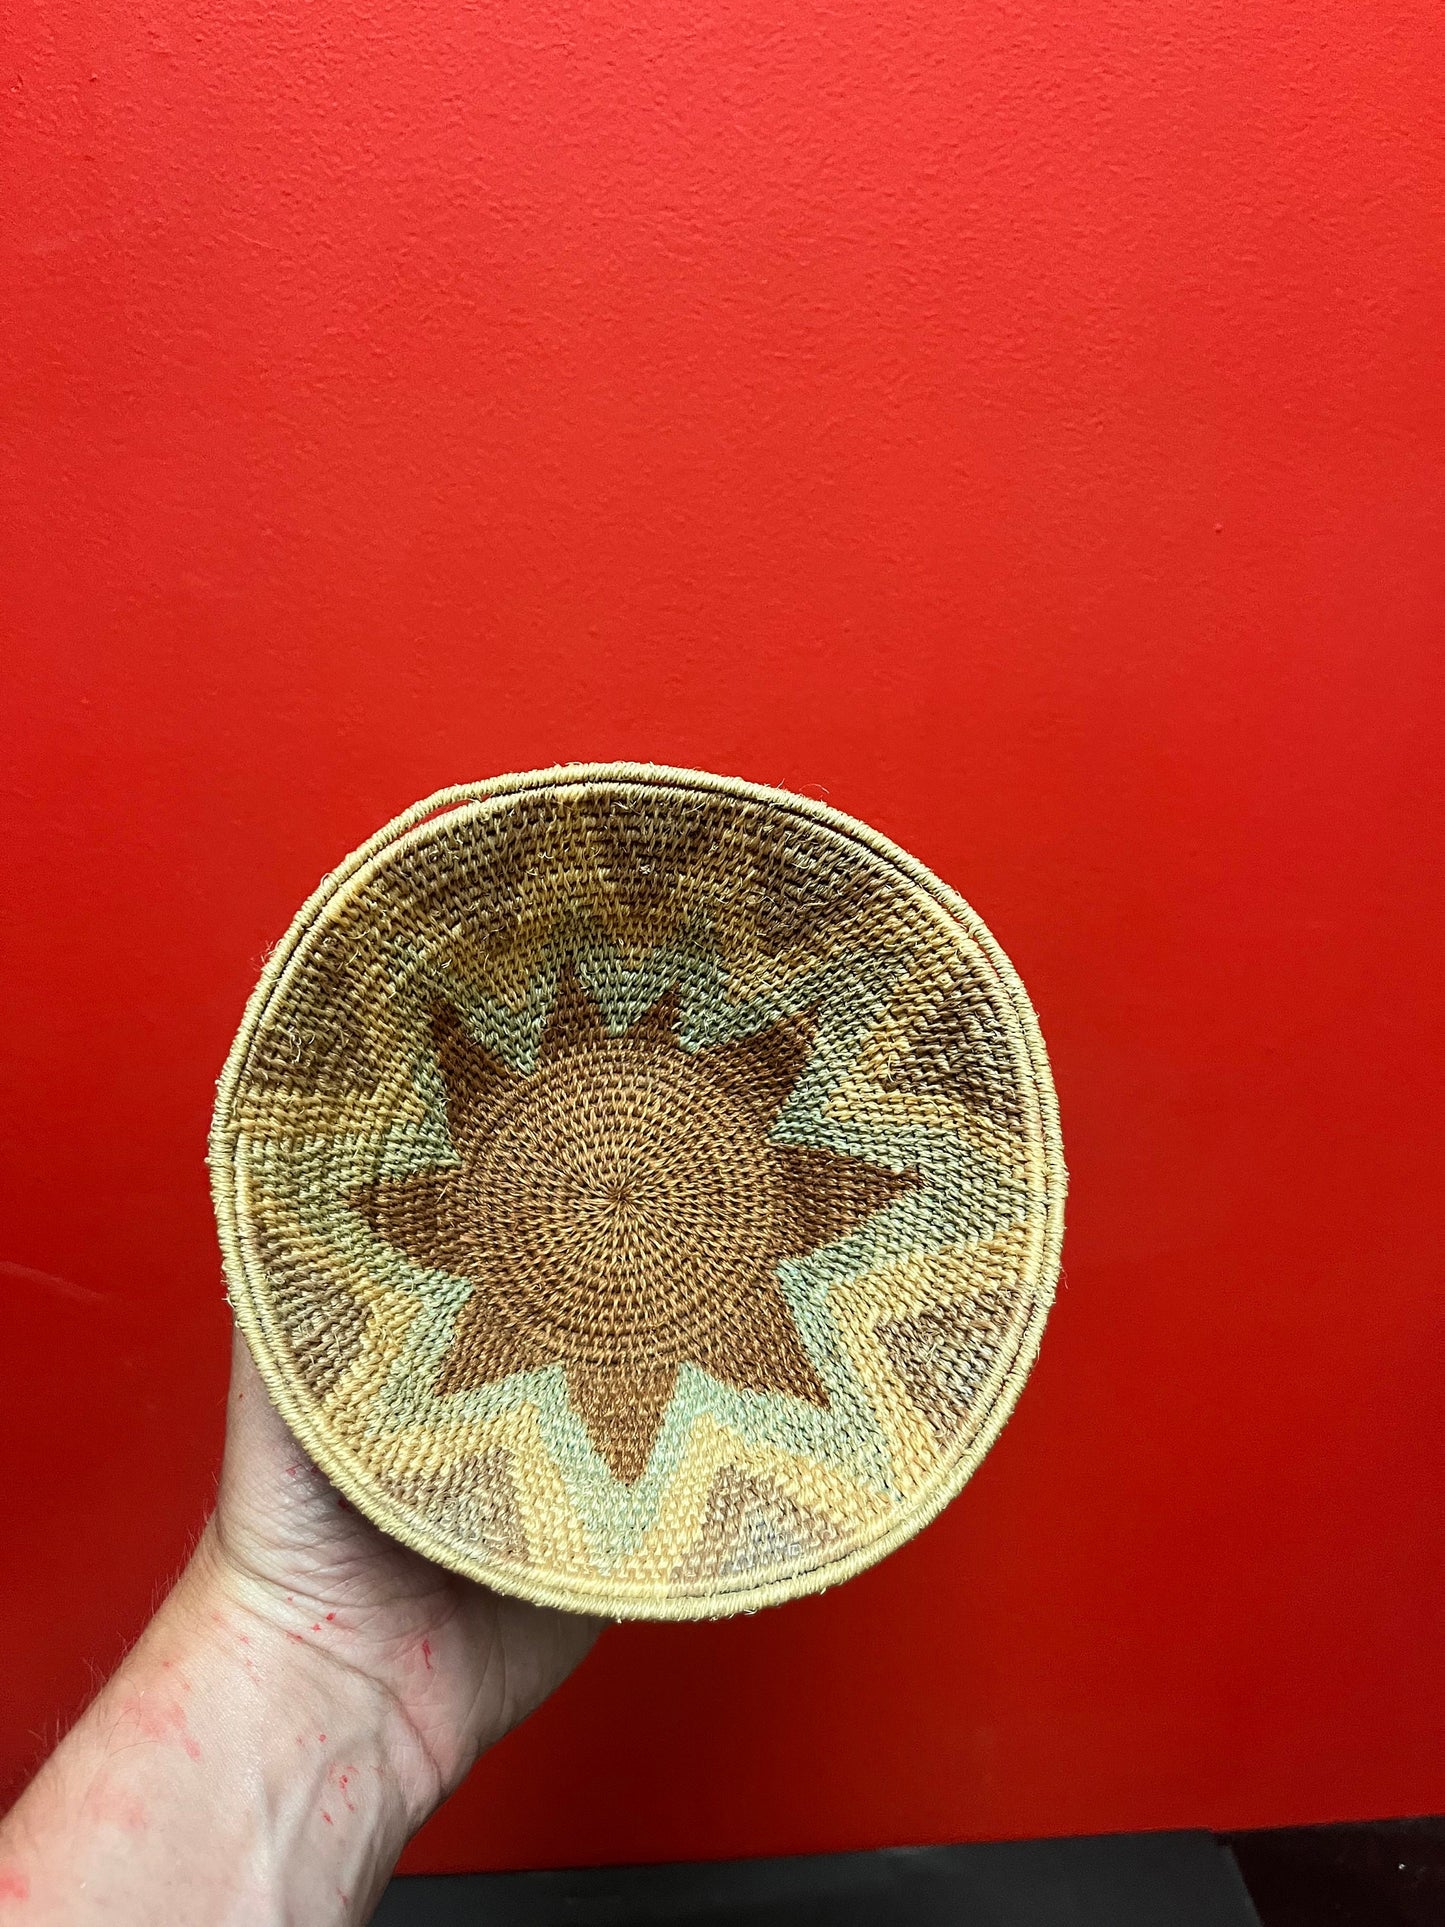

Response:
(0, 1337), (599, 1927)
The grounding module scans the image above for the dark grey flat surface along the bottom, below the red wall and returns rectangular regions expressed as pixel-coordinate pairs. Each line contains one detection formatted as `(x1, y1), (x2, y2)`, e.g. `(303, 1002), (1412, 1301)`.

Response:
(376, 1833), (1258, 1927)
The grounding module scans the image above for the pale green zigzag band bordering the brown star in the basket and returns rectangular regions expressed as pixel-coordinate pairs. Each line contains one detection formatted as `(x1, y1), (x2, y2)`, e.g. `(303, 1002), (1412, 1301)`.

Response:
(256, 929), (1027, 1572)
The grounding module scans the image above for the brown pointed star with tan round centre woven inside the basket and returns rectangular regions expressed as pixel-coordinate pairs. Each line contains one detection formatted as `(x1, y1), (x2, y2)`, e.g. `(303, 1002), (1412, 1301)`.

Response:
(351, 969), (919, 1484)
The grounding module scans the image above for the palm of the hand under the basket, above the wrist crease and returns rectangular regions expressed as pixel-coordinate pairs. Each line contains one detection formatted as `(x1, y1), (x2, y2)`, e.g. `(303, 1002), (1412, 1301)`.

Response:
(212, 1333), (601, 1794)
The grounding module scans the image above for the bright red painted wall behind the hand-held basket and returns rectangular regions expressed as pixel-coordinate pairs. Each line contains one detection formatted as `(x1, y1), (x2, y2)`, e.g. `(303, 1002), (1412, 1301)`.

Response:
(0, 0), (1445, 1867)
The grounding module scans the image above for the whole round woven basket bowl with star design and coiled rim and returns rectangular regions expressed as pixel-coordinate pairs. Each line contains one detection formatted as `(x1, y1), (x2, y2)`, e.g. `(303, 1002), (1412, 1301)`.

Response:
(210, 763), (1064, 1619)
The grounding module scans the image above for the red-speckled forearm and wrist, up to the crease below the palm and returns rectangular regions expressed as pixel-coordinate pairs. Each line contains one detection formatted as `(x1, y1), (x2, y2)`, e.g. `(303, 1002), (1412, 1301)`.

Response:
(0, 1542), (435, 1927)
